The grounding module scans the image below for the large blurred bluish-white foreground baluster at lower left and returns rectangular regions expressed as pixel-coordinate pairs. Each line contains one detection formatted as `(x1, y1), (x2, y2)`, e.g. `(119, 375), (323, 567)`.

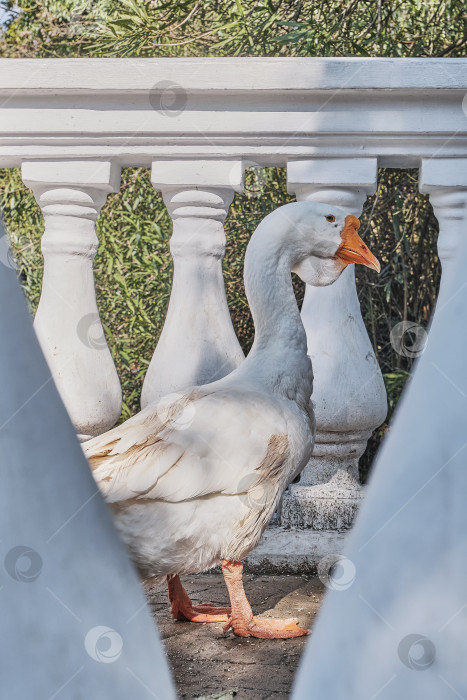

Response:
(0, 216), (175, 700)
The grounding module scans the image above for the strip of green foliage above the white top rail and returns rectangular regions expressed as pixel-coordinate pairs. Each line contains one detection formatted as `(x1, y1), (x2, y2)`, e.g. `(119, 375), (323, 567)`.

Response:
(0, 0), (467, 56)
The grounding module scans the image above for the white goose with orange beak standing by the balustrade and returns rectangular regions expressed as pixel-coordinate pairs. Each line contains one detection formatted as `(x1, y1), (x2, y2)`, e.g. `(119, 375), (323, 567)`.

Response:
(83, 202), (379, 638)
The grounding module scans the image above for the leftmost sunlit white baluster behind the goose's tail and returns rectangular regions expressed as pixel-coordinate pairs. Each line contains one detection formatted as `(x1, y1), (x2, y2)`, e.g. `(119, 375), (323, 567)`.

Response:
(22, 161), (122, 439)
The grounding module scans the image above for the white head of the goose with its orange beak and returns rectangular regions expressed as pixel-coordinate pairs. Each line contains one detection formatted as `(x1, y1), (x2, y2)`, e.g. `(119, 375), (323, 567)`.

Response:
(278, 202), (380, 287)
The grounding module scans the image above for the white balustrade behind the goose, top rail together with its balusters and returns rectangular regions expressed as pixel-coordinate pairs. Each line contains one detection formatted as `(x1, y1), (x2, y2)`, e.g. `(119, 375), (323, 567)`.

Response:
(0, 58), (467, 566)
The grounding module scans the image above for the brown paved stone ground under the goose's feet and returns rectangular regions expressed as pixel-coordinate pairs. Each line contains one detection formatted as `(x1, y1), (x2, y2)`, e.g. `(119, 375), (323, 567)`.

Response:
(146, 574), (323, 700)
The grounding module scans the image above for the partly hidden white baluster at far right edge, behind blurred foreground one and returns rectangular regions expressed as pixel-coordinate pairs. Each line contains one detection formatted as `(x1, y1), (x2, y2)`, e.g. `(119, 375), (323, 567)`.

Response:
(419, 158), (467, 313)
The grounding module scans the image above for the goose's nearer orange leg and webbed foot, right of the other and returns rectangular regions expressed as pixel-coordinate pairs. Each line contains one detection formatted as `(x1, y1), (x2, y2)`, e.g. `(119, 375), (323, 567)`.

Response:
(222, 559), (309, 639)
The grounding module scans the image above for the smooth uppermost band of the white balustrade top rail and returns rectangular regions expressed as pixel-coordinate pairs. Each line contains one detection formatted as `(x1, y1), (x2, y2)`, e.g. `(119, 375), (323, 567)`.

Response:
(0, 58), (467, 94)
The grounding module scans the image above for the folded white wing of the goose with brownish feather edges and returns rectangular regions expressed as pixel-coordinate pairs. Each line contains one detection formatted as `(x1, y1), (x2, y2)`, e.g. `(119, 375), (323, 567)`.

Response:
(83, 389), (290, 503)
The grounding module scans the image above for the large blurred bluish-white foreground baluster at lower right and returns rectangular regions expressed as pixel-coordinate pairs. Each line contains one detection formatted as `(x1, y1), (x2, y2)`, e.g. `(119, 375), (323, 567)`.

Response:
(292, 182), (467, 700)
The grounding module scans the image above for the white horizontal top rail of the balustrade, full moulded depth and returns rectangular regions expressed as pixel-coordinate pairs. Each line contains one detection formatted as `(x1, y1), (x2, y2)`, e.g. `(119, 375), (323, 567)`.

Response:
(0, 58), (467, 167)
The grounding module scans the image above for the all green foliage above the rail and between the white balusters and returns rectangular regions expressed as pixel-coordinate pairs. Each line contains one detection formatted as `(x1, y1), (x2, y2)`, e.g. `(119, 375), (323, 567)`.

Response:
(0, 0), (460, 482)
